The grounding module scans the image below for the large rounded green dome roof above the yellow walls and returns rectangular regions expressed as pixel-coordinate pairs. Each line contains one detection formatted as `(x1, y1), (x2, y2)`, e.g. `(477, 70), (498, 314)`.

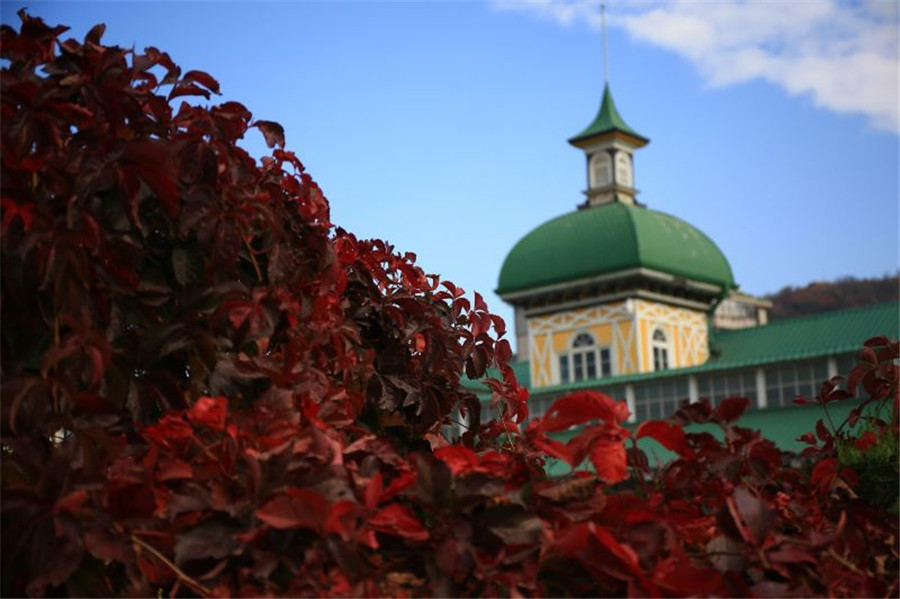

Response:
(497, 202), (734, 295)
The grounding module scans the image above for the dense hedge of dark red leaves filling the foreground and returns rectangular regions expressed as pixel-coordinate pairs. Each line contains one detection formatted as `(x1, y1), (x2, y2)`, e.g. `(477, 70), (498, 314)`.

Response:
(0, 12), (898, 597)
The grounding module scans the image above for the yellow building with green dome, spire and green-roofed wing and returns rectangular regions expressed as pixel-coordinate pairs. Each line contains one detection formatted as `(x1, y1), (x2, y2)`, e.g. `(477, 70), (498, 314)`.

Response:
(497, 85), (900, 449)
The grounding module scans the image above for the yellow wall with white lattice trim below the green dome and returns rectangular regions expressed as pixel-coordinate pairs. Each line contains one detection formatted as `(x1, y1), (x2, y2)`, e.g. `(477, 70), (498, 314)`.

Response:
(528, 299), (709, 388)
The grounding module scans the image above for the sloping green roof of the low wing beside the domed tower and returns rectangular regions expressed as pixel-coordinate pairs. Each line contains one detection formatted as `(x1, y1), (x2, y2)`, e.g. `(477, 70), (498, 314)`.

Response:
(516, 302), (900, 395)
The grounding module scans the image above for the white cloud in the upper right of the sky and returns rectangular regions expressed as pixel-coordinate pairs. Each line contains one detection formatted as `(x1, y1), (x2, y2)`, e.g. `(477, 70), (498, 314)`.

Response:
(493, 0), (900, 132)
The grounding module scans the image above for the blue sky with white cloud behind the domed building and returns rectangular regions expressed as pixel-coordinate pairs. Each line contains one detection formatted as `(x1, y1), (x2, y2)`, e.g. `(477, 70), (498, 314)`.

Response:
(0, 0), (900, 352)
